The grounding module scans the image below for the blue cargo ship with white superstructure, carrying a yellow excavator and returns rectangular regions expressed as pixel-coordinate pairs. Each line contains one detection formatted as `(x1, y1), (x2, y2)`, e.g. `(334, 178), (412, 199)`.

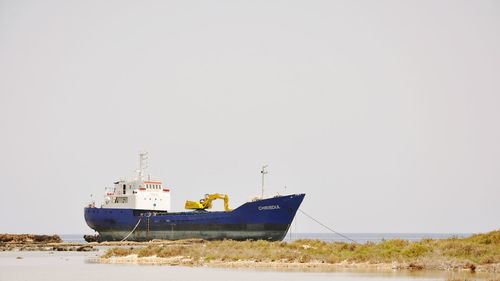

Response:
(84, 153), (305, 241)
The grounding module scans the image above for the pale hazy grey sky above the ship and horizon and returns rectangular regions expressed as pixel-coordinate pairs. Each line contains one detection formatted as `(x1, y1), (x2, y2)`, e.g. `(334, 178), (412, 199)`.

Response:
(0, 0), (500, 233)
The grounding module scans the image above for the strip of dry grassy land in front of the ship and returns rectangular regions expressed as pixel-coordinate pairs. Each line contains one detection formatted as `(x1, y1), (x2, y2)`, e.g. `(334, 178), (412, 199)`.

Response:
(103, 230), (500, 271)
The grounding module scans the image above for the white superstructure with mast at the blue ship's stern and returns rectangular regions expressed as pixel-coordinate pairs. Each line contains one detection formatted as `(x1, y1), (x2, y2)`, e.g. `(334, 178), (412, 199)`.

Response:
(102, 153), (170, 211)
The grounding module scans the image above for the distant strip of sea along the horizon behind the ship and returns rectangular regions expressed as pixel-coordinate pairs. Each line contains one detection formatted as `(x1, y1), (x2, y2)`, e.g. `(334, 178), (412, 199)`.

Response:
(61, 233), (471, 243)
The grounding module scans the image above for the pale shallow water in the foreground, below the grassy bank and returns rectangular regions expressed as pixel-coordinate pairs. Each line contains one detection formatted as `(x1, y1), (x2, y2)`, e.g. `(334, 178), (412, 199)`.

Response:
(0, 249), (494, 281)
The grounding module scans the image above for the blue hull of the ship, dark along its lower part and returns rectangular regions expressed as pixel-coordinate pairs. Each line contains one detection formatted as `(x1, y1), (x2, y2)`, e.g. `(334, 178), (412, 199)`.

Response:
(85, 194), (305, 241)
